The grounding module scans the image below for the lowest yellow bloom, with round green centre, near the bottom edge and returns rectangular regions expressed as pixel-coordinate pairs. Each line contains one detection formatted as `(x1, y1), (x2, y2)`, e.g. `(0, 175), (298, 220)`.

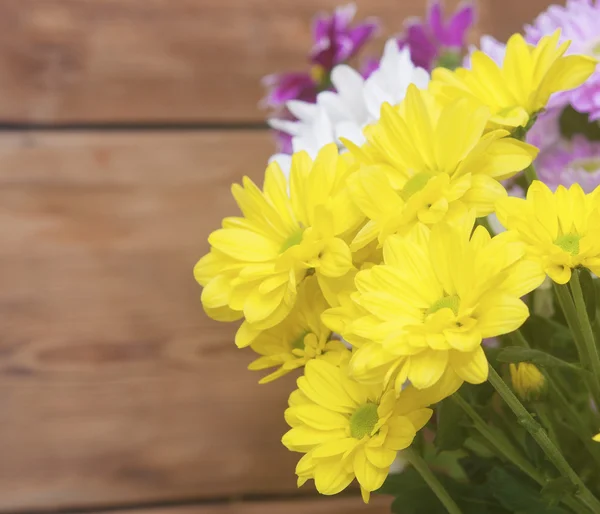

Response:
(282, 360), (461, 502)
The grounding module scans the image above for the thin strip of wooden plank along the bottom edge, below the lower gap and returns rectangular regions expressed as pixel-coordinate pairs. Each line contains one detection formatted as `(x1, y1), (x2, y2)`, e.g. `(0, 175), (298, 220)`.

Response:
(98, 496), (391, 514)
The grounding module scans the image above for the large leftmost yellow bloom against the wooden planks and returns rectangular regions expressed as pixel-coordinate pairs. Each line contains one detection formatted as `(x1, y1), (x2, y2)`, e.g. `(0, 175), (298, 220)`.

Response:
(194, 144), (363, 347)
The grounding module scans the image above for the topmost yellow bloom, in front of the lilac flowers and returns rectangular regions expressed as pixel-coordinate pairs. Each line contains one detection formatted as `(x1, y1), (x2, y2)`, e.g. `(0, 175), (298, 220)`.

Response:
(430, 30), (597, 129)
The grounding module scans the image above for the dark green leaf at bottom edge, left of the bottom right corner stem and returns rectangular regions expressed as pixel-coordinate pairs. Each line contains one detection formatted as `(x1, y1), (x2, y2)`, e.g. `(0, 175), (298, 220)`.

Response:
(487, 467), (567, 514)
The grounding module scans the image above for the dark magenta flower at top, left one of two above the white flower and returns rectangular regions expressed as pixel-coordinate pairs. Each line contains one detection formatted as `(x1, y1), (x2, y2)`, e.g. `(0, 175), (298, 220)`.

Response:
(310, 4), (379, 71)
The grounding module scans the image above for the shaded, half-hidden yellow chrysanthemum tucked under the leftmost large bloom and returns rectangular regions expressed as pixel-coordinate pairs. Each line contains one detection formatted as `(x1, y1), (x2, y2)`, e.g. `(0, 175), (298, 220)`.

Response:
(248, 277), (348, 384)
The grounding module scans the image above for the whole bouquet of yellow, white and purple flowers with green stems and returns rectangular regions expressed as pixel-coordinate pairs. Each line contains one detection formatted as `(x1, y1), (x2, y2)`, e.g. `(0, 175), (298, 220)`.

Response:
(194, 0), (600, 514)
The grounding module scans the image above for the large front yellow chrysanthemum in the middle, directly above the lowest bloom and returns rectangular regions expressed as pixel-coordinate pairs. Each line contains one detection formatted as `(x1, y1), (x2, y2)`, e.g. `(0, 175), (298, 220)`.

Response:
(336, 218), (544, 391)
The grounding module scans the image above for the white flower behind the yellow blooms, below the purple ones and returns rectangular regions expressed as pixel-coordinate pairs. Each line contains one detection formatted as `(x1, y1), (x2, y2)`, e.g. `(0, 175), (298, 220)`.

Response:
(269, 39), (429, 173)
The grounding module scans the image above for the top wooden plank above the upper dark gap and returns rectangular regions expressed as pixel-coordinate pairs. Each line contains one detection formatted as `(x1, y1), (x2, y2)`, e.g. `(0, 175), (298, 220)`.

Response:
(0, 0), (474, 123)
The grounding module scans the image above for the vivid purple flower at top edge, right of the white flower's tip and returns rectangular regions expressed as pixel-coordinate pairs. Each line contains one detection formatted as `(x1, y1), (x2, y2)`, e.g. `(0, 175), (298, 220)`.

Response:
(398, 0), (475, 70)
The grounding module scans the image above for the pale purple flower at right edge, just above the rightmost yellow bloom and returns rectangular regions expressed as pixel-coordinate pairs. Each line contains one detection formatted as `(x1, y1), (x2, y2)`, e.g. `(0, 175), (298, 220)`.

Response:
(536, 135), (600, 193)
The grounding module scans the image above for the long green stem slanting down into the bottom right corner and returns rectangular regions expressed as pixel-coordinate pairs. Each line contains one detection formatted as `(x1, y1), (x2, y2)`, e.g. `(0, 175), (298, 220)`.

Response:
(488, 366), (600, 512)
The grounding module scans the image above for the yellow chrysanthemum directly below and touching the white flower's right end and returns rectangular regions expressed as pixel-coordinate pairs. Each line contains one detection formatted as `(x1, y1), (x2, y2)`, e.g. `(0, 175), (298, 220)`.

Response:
(348, 85), (537, 251)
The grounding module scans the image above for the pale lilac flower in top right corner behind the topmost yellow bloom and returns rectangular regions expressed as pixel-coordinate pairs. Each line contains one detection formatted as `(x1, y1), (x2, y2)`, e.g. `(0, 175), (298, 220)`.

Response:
(525, 0), (600, 121)
